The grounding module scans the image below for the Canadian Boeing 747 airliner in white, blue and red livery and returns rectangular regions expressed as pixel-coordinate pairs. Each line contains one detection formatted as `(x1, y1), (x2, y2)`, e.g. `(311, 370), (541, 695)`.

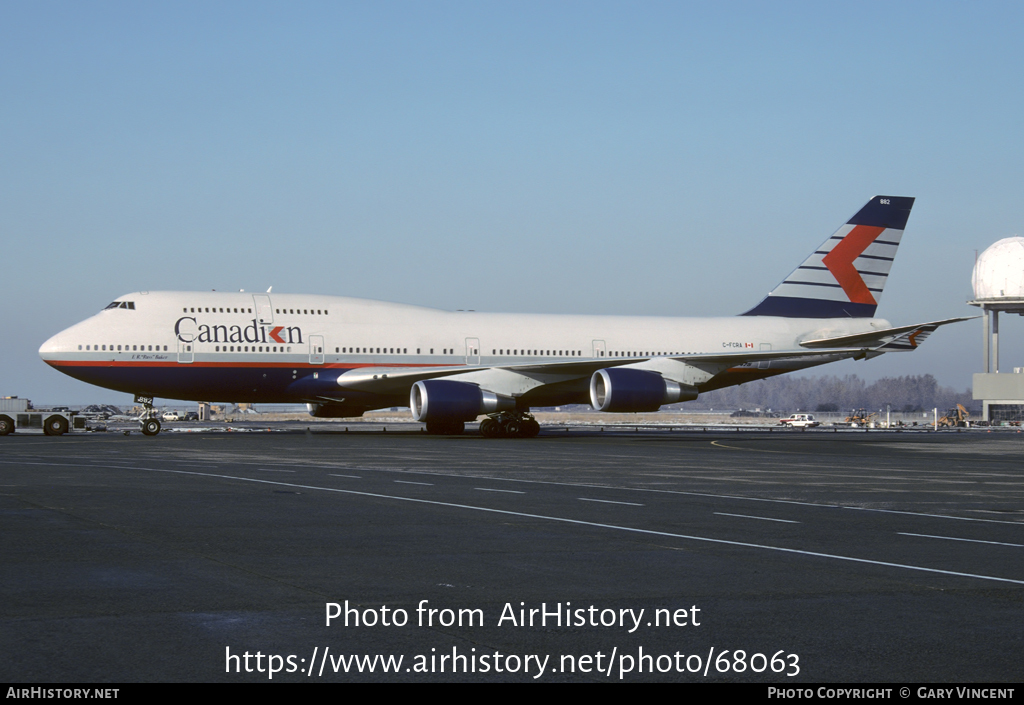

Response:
(34, 196), (965, 437)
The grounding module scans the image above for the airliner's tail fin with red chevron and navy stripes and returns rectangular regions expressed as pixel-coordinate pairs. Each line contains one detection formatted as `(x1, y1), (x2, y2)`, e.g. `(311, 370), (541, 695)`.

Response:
(743, 196), (913, 319)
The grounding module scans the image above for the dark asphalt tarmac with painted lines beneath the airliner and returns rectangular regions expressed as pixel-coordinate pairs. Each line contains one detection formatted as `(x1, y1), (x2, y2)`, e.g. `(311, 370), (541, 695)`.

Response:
(0, 423), (1024, 687)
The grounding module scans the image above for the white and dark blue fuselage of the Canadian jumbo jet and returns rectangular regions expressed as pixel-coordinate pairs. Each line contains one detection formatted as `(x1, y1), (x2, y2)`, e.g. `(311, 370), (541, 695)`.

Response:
(40, 292), (889, 408)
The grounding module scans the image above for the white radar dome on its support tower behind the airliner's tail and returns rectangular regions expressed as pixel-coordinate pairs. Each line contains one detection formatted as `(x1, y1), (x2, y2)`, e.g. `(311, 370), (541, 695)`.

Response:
(968, 238), (1024, 423)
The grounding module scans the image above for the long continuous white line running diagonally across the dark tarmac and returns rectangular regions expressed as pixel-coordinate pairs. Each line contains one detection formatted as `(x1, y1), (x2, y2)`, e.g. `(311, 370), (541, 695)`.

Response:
(49, 465), (1024, 585)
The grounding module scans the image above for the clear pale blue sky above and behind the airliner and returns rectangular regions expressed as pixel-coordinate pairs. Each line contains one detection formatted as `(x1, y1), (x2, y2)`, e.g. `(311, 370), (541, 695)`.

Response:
(0, 0), (1024, 403)
